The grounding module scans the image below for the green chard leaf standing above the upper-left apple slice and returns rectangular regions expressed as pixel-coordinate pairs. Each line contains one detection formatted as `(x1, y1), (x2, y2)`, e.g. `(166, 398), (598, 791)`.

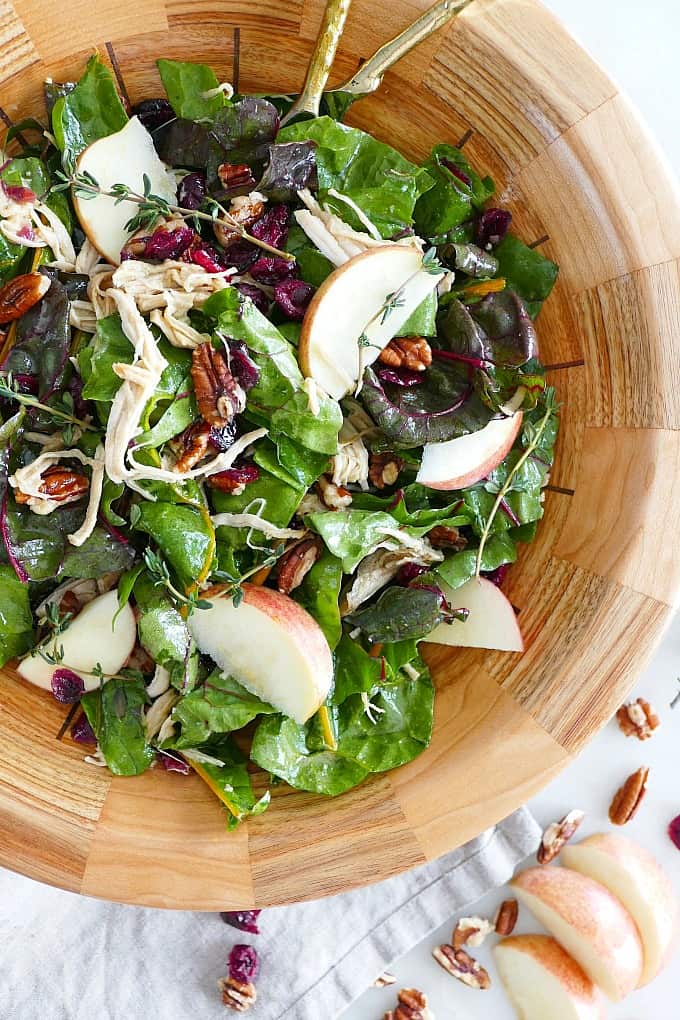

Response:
(52, 53), (127, 170)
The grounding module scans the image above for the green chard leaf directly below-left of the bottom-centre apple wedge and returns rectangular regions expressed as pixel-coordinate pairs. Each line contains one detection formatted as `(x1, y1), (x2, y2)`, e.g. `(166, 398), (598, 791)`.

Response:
(169, 670), (276, 750)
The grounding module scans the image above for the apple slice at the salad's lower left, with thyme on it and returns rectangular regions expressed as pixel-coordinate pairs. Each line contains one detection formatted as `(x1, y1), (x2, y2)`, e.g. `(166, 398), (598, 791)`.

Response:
(17, 590), (137, 691)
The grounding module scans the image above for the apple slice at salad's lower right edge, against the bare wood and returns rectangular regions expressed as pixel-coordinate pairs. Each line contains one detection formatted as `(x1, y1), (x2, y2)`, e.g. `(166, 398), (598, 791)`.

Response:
(425, 577), (524, 652)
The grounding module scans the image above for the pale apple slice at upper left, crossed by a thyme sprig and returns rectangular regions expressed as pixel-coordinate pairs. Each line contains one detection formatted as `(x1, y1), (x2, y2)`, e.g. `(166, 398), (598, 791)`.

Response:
(73, 117), (177, 265)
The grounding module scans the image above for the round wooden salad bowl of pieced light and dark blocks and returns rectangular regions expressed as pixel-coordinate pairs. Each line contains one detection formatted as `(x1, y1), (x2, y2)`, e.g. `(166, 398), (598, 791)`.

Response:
(0, 0), (680, 910)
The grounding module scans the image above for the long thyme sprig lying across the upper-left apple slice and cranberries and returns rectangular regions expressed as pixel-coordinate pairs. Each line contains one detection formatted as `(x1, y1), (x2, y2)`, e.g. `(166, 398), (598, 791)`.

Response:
(51, 170), (295, 262)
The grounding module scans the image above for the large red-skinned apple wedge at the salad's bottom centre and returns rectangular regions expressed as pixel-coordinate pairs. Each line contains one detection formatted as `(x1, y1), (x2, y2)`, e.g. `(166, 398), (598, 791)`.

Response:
(188, 584), (333, 723)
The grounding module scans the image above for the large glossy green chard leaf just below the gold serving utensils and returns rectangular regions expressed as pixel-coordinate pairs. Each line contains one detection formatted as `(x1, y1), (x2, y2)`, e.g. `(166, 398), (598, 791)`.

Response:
(277, 117), (432, 238)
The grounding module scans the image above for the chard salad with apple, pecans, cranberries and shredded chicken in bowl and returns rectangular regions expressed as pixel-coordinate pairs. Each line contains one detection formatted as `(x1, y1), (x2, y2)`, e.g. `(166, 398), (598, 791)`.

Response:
(0, 55), (558, 825)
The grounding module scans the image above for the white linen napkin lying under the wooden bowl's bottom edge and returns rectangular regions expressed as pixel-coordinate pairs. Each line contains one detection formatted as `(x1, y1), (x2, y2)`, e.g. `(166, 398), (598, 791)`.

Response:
(0, 809), (540, 1020)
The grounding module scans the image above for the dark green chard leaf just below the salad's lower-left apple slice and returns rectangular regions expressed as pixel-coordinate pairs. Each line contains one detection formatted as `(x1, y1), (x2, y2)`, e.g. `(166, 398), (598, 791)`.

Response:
(81, 678), (155, 775)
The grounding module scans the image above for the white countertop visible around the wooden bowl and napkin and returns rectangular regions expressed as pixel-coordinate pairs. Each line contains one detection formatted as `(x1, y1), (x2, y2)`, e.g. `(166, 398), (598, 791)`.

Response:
(342, 0), (680, 1020)
